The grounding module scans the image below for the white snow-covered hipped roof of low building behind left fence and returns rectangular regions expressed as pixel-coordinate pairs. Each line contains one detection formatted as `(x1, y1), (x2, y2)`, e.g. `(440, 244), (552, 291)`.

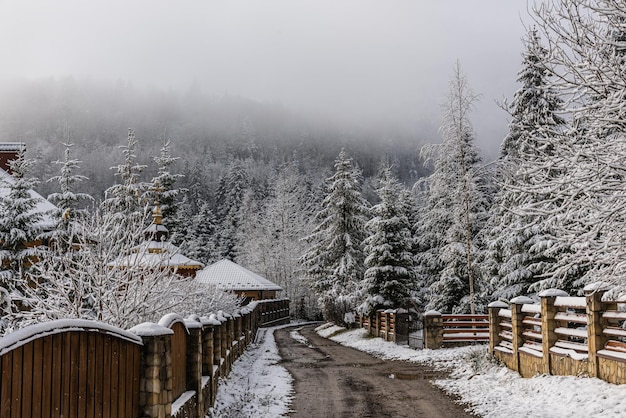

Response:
(195, 259), (283, 291)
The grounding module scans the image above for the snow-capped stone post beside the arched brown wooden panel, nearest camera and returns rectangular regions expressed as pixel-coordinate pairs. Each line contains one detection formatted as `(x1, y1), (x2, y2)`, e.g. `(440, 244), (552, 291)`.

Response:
(129, 322), (174, 418)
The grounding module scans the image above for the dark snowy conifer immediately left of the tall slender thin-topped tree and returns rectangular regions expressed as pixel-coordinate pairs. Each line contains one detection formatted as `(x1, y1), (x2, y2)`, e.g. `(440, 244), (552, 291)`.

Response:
(358, 165), (415, 316)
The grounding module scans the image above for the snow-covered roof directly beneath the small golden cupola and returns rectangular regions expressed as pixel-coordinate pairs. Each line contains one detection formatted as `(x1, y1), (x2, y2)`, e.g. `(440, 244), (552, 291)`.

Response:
(109, 241), (204, 269)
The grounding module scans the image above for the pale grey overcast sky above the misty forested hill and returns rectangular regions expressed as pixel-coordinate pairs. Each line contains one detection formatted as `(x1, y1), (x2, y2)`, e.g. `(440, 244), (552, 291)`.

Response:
(0, 0), (529, 155)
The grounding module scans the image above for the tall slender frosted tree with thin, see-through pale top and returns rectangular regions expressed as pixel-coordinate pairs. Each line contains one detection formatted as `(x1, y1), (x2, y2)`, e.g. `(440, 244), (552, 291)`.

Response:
(418, 63), (489, 313)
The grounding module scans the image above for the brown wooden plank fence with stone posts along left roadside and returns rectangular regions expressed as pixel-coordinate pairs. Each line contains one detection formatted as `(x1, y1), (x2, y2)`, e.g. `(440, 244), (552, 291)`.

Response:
(0, 299), (289, 418)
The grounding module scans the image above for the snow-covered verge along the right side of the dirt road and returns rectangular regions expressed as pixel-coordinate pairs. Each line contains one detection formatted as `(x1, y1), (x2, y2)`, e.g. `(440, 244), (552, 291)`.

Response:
(318, 325), (626, 418)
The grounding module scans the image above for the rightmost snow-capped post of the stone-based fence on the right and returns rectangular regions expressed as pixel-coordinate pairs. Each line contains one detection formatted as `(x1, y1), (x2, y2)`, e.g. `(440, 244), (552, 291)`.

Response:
(584, 284), (608, 377)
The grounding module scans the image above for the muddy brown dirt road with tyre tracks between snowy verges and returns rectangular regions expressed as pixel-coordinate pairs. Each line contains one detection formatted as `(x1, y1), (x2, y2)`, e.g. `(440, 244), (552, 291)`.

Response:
(274, 325), (473, 418)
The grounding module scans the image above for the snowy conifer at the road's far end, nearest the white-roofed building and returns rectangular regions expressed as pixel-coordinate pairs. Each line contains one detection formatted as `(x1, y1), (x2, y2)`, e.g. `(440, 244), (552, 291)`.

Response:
(300, 149), (369, 322)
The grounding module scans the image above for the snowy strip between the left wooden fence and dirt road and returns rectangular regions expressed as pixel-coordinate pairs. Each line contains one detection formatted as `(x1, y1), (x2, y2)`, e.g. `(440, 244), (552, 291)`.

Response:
(209, 324), (293, 418)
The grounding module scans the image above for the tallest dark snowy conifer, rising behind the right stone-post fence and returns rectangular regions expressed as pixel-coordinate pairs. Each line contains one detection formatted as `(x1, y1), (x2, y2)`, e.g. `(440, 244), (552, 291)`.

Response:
(484, 29), (565, 299)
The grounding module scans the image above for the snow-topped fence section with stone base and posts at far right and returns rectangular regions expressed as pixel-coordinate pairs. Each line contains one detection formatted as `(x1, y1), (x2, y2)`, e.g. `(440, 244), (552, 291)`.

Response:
(489, 286), (626, 384)
